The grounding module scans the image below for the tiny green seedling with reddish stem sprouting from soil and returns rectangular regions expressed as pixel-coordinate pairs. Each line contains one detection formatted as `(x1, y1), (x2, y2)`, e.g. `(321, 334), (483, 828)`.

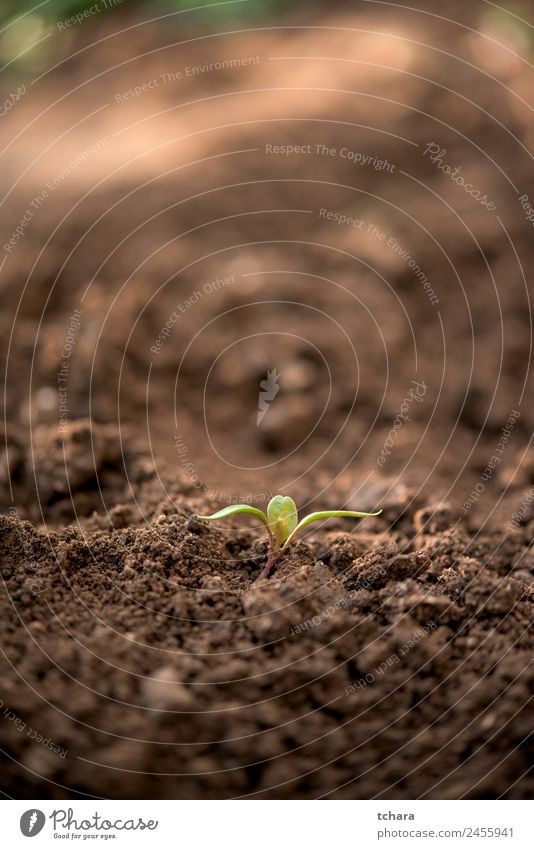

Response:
(197, 495), (382, 578)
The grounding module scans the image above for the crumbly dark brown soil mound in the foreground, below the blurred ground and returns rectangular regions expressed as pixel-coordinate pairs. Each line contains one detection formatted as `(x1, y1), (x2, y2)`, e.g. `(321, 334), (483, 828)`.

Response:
(0, 450), (534, 799)
